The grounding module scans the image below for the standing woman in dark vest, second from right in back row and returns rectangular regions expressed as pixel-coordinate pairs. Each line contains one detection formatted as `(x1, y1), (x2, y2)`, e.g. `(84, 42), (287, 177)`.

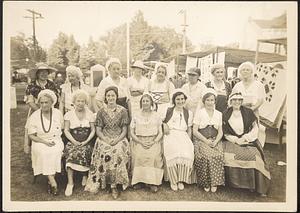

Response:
(205, 64), (232, 112)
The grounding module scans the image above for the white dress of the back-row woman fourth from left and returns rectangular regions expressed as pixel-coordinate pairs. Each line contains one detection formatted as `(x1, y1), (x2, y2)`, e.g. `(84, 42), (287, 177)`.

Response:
(127, 76), (149, 114)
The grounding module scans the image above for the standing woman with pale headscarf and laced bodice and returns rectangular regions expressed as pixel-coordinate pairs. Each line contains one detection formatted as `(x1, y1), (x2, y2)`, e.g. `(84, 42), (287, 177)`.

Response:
(148, 63), (175, 117)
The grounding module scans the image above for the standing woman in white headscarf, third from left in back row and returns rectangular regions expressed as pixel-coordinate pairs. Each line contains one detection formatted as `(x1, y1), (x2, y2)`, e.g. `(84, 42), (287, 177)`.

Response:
(95, 58), (130, 111)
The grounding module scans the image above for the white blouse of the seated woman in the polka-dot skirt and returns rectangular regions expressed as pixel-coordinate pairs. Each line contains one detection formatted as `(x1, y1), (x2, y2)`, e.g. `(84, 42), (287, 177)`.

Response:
(194, 108), (222, 129)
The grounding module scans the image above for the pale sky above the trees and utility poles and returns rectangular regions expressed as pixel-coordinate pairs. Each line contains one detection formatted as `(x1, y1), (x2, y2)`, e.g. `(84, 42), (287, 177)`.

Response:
(3, 1), (287, 48)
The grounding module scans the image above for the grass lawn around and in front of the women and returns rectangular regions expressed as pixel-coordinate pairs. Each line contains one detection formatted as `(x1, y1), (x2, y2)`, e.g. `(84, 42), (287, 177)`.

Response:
(10, 104), (286, 202)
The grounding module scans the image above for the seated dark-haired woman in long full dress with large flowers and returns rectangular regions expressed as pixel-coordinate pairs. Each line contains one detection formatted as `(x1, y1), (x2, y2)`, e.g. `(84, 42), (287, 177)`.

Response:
(85, 86), (130, 199)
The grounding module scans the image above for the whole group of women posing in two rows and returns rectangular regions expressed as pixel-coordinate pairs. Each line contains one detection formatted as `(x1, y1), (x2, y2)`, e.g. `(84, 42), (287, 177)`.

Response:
(24, 58), (271, 199)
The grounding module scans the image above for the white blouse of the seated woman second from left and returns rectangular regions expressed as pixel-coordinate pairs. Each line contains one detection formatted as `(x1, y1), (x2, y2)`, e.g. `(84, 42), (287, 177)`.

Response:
(64, 108), (96, 129)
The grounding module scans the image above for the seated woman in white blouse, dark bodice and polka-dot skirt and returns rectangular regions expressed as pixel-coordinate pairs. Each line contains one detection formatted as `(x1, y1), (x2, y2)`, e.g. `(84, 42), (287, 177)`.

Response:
(193, 88), (225, 192)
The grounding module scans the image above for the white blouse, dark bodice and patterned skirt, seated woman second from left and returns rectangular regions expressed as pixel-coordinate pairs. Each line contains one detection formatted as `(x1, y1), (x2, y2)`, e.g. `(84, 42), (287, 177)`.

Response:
(64, 108), (95, 172)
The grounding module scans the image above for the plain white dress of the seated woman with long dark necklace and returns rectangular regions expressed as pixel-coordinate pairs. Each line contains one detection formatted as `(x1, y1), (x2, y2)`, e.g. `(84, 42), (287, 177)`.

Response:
(28, 108), (64, 175)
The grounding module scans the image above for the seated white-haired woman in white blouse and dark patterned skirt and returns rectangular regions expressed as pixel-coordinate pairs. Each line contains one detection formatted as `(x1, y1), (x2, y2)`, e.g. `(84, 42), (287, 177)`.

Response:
(64, 89), (95, 196)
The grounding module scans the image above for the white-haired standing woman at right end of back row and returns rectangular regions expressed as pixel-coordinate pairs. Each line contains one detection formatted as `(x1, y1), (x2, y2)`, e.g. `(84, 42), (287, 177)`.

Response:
(232, 61), (266, 118)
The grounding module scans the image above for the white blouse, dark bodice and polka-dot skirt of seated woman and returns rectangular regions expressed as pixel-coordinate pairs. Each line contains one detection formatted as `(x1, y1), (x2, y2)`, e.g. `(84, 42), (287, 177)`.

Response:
(194, 108), (225, 188)
